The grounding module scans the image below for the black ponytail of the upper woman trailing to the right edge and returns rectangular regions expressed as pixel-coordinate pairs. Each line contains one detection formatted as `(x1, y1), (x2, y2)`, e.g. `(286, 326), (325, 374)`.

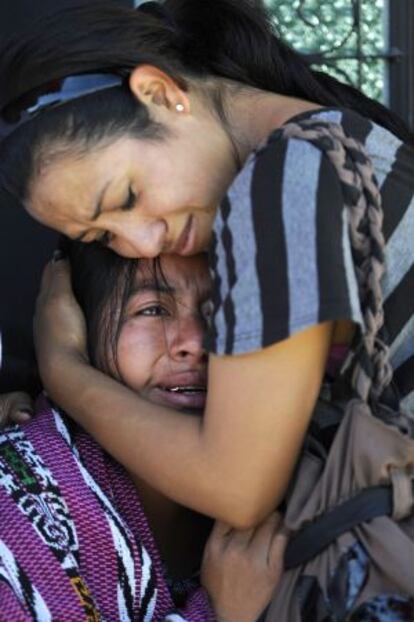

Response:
(164, 0), (414, 143)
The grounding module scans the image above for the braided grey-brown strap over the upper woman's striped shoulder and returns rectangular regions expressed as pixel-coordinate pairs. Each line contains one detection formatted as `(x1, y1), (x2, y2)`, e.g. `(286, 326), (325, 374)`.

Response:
(282, 119), (392, 401)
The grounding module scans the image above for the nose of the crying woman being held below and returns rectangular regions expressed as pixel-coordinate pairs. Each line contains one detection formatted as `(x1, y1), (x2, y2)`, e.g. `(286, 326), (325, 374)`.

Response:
(170, 315), (207, 363)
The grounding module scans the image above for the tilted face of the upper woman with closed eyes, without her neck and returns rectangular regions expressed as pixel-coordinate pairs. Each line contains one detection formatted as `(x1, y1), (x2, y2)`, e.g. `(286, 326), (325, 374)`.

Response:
(27, 68), (236, 257)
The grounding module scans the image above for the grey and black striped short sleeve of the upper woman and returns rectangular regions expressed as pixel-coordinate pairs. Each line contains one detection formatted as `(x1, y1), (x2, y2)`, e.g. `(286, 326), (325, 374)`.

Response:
(206, 132), (362, 354)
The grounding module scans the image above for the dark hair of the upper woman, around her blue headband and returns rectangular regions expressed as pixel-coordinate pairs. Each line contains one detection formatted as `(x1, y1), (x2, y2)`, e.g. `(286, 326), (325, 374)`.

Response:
(0, 0), (413, 205)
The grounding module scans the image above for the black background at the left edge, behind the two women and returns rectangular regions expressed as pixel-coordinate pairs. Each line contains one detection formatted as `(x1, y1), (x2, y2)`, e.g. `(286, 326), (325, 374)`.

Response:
(0, 0), (133, 393)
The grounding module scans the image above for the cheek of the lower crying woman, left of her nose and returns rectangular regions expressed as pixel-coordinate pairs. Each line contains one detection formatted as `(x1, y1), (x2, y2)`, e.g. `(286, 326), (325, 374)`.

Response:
(117, 318), (165, 391)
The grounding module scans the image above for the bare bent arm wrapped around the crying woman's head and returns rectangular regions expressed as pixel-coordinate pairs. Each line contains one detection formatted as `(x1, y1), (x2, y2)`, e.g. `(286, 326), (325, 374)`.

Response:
(37, 264), (332, 528)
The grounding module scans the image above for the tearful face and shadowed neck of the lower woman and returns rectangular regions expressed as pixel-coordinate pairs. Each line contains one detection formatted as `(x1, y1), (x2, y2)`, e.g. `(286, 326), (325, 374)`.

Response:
(107, 255), (211, 577)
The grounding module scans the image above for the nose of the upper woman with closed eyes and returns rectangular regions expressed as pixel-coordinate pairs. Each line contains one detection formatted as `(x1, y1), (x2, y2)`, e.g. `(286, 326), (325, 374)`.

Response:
(110, 220), (167, 259)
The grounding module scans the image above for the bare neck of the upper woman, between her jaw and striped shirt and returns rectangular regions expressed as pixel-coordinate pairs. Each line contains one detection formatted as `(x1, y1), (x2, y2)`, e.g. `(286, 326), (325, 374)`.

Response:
(227, 89), (321, 163)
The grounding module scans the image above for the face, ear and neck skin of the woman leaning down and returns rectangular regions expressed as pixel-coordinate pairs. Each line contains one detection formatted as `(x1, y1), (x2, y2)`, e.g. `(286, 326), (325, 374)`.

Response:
(26, 66), (317, 257)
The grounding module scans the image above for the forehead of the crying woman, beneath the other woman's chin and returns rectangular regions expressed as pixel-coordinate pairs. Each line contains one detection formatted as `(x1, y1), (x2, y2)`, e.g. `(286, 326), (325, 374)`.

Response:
(136, 253), (211, 296)
